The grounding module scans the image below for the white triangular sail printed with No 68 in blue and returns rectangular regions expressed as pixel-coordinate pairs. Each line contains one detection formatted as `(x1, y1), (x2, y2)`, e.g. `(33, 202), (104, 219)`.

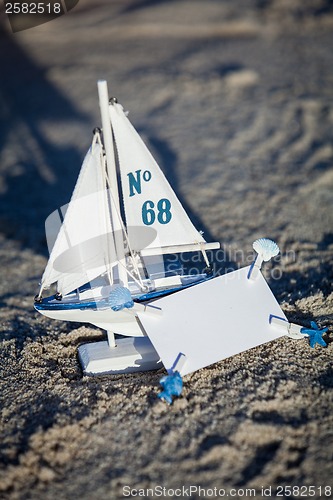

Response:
(109, 103), (205, 254)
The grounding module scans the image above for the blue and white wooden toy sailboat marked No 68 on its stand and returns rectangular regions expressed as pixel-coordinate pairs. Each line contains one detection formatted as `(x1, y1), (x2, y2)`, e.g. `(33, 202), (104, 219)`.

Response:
(35, 81), (220, 373)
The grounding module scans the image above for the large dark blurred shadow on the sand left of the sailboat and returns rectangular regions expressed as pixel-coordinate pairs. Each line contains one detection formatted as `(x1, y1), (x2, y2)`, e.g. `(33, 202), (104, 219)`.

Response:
(0, 27), (90, 254)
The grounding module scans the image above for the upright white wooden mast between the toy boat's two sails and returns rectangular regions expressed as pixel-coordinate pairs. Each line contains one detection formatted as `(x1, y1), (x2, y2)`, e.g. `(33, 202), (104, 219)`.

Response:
(97, 80), (128, 286)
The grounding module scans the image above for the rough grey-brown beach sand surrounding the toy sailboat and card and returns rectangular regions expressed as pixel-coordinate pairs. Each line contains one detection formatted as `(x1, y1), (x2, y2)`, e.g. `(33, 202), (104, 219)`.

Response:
(0, 0), (333, 500)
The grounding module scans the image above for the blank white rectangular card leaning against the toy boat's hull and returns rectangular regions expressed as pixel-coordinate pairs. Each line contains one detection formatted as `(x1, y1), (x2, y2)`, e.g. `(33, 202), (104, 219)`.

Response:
(138, 267), (286, 375)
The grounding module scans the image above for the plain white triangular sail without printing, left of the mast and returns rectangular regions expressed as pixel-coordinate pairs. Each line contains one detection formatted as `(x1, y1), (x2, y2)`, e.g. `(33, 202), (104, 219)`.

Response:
(42, 143), (116, 295)
